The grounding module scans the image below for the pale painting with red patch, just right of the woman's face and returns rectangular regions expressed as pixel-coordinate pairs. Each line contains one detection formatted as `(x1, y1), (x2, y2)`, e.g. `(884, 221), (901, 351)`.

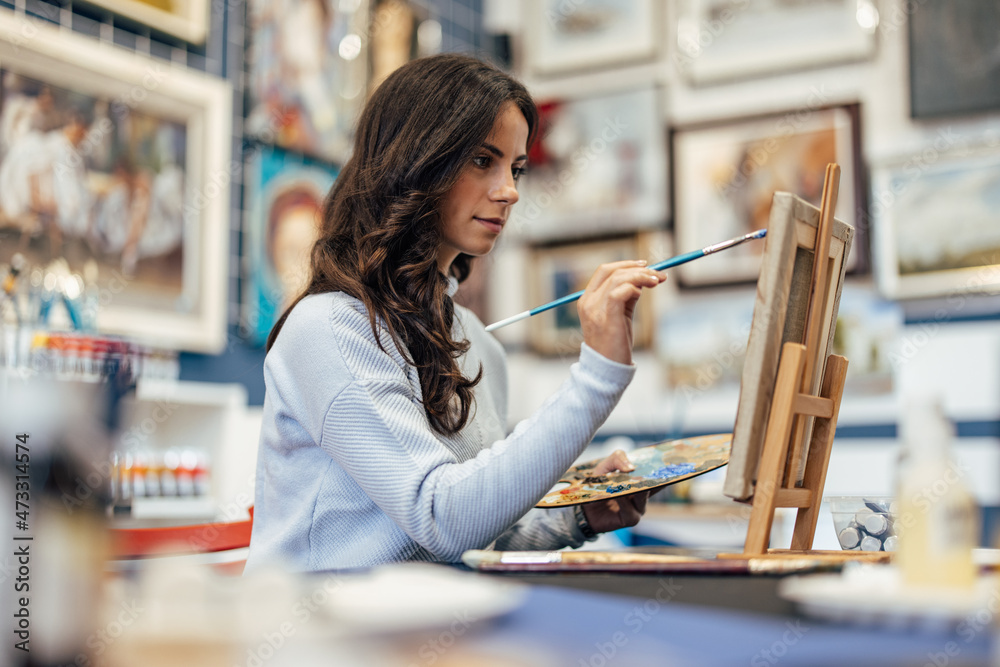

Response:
(512, 86), (668, 241)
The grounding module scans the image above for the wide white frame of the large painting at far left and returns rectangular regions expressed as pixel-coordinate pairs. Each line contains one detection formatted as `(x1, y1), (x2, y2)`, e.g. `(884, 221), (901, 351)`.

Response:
(0, 11), (233, 353)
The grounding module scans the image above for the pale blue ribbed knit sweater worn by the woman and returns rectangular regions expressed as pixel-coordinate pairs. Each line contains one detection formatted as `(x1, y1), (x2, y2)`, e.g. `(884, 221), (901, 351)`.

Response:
(247, 292), (634, 571)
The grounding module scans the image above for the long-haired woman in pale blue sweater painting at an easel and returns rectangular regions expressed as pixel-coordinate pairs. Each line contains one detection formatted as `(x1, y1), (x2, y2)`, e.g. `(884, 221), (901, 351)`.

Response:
(247, 55), (665, 570)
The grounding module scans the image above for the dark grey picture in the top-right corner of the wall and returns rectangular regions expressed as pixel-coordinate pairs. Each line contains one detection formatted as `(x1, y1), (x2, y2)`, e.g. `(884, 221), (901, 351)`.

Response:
(907, 0), (1000, 118)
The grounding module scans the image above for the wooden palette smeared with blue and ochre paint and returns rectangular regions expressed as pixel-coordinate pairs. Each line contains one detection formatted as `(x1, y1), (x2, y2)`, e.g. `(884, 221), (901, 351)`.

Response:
(536, 433), (733, 507)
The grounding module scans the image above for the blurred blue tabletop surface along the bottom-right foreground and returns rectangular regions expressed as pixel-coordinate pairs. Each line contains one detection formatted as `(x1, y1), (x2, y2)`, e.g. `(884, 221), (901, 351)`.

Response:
(466, 579), (995, 667)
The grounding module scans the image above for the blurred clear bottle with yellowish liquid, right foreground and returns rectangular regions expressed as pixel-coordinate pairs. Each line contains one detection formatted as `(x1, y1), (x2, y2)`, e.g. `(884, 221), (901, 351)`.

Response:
(895, 397), (979, 588)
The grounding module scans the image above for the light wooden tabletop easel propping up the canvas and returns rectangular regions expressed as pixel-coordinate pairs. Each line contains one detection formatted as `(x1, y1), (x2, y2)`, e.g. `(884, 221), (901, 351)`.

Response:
(719, 164), (889, 561)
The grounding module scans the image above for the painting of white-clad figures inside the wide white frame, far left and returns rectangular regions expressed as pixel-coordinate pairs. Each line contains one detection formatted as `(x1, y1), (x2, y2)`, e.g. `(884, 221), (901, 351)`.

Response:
(0, 70), (186, 312)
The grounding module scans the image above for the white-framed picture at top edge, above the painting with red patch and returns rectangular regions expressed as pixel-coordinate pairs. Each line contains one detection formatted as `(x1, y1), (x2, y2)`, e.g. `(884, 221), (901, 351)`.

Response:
(523, 0), (658, 74)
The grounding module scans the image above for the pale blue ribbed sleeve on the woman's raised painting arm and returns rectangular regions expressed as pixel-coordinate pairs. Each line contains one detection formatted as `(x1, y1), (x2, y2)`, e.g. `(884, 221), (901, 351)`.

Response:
(320, 341), (634, 561)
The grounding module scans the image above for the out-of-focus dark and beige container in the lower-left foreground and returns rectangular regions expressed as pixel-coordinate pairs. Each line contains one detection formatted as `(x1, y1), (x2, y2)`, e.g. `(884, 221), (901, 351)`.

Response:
(0, 366), (131, 665)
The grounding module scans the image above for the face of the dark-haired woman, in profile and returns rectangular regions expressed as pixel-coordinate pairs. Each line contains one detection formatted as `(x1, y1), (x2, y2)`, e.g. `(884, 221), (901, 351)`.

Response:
(438, 102), (528, 273)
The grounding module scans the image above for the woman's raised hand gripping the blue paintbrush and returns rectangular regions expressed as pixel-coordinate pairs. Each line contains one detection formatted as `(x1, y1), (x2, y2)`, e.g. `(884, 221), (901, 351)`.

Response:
(577, 260), (667, 364)
